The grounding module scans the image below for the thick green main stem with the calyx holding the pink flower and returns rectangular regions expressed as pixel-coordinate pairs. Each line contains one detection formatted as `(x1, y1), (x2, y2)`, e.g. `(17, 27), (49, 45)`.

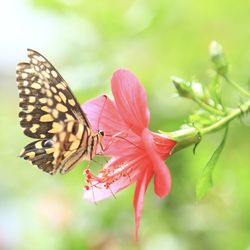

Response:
(166, 100), (250, 153)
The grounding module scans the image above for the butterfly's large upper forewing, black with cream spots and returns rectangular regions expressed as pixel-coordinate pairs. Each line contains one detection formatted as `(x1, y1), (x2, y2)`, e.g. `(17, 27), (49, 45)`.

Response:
(17, 50), (90, 139)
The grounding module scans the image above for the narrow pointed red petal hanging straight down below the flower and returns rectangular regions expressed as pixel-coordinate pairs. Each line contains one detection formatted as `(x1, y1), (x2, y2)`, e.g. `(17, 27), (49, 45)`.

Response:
(134, 168), (153, 240)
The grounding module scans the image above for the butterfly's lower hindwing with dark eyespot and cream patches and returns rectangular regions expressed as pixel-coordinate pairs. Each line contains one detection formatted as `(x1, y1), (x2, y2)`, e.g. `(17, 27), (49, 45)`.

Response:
(20, 121), (90, 175)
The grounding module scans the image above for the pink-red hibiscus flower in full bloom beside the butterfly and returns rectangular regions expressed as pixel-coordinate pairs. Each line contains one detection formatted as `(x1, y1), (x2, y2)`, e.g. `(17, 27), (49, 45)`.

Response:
(83, 70), (176, 238)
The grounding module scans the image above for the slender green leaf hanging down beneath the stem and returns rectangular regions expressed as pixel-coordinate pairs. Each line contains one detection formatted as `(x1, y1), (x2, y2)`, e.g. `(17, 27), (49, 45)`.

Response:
(196, 127), (228, 200)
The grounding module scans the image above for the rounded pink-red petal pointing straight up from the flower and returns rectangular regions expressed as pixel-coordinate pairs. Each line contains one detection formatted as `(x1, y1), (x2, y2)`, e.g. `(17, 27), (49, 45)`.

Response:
(111, 69), (149, 135)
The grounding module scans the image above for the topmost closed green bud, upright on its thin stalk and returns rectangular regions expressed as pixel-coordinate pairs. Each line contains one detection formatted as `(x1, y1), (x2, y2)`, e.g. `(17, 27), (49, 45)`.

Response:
(209, 41), (228, 76)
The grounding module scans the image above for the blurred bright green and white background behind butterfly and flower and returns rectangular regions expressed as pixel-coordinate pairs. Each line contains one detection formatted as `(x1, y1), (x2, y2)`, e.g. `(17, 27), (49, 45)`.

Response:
(0, 0), (250, 250)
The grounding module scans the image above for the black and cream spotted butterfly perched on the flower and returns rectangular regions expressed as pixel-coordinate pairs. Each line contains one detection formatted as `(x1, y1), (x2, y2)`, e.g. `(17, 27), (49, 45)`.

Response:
(16, 49), (104, 175)
